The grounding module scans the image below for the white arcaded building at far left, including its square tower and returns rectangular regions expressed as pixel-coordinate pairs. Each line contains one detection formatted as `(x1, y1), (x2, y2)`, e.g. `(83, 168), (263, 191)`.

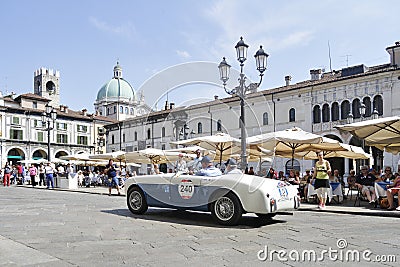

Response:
(0, 68), (115, 166)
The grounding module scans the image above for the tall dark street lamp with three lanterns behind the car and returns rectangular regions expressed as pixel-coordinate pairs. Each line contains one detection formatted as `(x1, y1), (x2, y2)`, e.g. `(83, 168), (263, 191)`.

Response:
(218, 37), (268, 170)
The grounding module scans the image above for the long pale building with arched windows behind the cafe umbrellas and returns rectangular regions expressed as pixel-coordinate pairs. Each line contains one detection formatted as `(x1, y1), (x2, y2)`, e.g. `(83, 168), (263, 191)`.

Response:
(106, 42), (400, 174)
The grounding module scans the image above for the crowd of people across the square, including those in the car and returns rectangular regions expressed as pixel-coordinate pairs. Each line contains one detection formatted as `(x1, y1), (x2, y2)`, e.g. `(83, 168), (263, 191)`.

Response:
(2, 150), (400, 211)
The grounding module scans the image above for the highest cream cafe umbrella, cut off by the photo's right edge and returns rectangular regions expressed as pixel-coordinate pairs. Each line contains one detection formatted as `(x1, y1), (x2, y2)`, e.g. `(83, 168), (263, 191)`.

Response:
(335, 116), (400, 154)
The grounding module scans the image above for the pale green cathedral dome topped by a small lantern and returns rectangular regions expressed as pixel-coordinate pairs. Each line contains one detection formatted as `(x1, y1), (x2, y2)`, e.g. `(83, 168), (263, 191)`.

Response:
(96, 62), (136, 102)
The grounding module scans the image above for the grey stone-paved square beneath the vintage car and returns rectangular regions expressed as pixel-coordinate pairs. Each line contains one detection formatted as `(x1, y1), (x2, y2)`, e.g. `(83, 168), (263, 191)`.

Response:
(0, 186), (400, 266)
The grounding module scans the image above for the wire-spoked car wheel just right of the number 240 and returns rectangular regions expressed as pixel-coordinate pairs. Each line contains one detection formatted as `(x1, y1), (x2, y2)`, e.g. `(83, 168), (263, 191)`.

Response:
(211, 192), (243, 225)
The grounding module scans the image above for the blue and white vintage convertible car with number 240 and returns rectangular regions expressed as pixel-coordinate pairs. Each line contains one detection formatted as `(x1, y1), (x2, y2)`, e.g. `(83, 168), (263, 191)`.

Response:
(125, 173), (300, 225)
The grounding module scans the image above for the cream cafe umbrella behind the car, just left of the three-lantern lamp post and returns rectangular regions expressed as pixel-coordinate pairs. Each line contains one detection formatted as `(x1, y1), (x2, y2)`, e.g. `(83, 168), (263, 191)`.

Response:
(171, 133), (241, 164)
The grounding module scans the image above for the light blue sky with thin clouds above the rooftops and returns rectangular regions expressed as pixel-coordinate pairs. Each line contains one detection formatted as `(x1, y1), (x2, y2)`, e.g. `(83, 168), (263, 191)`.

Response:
(0, 0), (400, 111)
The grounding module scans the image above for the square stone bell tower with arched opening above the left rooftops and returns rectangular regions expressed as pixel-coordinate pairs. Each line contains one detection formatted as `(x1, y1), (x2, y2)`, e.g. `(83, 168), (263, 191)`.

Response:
(33, 68), (60, 107)
